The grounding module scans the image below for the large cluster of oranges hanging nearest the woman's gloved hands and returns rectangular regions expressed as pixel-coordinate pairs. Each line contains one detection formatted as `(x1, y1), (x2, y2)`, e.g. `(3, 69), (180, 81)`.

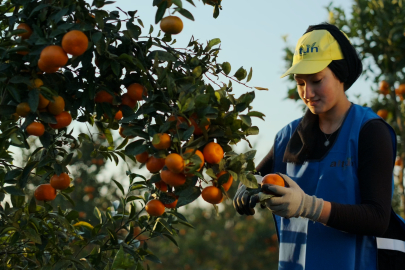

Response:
(135, 124), (233, 216)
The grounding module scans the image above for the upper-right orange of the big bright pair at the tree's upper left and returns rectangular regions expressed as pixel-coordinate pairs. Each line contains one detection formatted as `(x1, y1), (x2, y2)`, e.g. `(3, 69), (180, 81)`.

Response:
(62, 30), (89, 56)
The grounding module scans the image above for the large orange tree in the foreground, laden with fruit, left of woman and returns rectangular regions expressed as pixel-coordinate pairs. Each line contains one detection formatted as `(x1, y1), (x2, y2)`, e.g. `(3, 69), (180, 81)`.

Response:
(0, 0), (264, 269)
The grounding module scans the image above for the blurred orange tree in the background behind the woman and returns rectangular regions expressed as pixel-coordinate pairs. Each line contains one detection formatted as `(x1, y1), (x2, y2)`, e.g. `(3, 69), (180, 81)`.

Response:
(285, 0), (405, 216)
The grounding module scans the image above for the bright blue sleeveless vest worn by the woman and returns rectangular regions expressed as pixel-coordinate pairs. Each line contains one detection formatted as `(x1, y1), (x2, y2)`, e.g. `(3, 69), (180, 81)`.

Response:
(274, 105), (405, 270)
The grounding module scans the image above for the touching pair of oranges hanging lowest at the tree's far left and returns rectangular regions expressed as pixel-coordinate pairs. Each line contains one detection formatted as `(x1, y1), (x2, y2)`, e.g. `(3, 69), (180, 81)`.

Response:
(34, 173), (70, 201)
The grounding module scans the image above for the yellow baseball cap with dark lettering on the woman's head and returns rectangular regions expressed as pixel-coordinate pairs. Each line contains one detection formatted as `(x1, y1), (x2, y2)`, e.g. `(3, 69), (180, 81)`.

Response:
(281, 30), (347, 78)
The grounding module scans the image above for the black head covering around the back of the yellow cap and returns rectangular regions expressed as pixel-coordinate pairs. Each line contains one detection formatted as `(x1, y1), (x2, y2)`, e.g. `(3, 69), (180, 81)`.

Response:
(304, 22), (363, 91)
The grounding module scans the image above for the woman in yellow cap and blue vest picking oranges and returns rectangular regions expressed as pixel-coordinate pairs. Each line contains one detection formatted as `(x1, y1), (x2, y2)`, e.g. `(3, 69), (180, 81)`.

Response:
(234, 24), (405, 270)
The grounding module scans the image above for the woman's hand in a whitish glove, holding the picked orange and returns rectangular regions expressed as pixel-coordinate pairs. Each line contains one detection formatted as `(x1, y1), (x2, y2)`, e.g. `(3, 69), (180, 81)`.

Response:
(262, 173), (323, 221)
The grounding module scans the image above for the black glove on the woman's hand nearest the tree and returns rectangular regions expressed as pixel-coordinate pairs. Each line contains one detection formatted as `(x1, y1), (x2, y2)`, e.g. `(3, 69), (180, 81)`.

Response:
(233, 184), (266, 216)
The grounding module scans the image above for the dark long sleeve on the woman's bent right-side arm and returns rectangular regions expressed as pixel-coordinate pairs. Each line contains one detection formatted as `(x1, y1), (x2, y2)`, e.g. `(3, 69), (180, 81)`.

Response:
(327, 119), (394, 236)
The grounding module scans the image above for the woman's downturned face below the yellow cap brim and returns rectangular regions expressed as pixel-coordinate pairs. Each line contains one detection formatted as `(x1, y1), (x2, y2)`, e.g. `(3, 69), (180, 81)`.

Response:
(294, 67), (346, 114)
